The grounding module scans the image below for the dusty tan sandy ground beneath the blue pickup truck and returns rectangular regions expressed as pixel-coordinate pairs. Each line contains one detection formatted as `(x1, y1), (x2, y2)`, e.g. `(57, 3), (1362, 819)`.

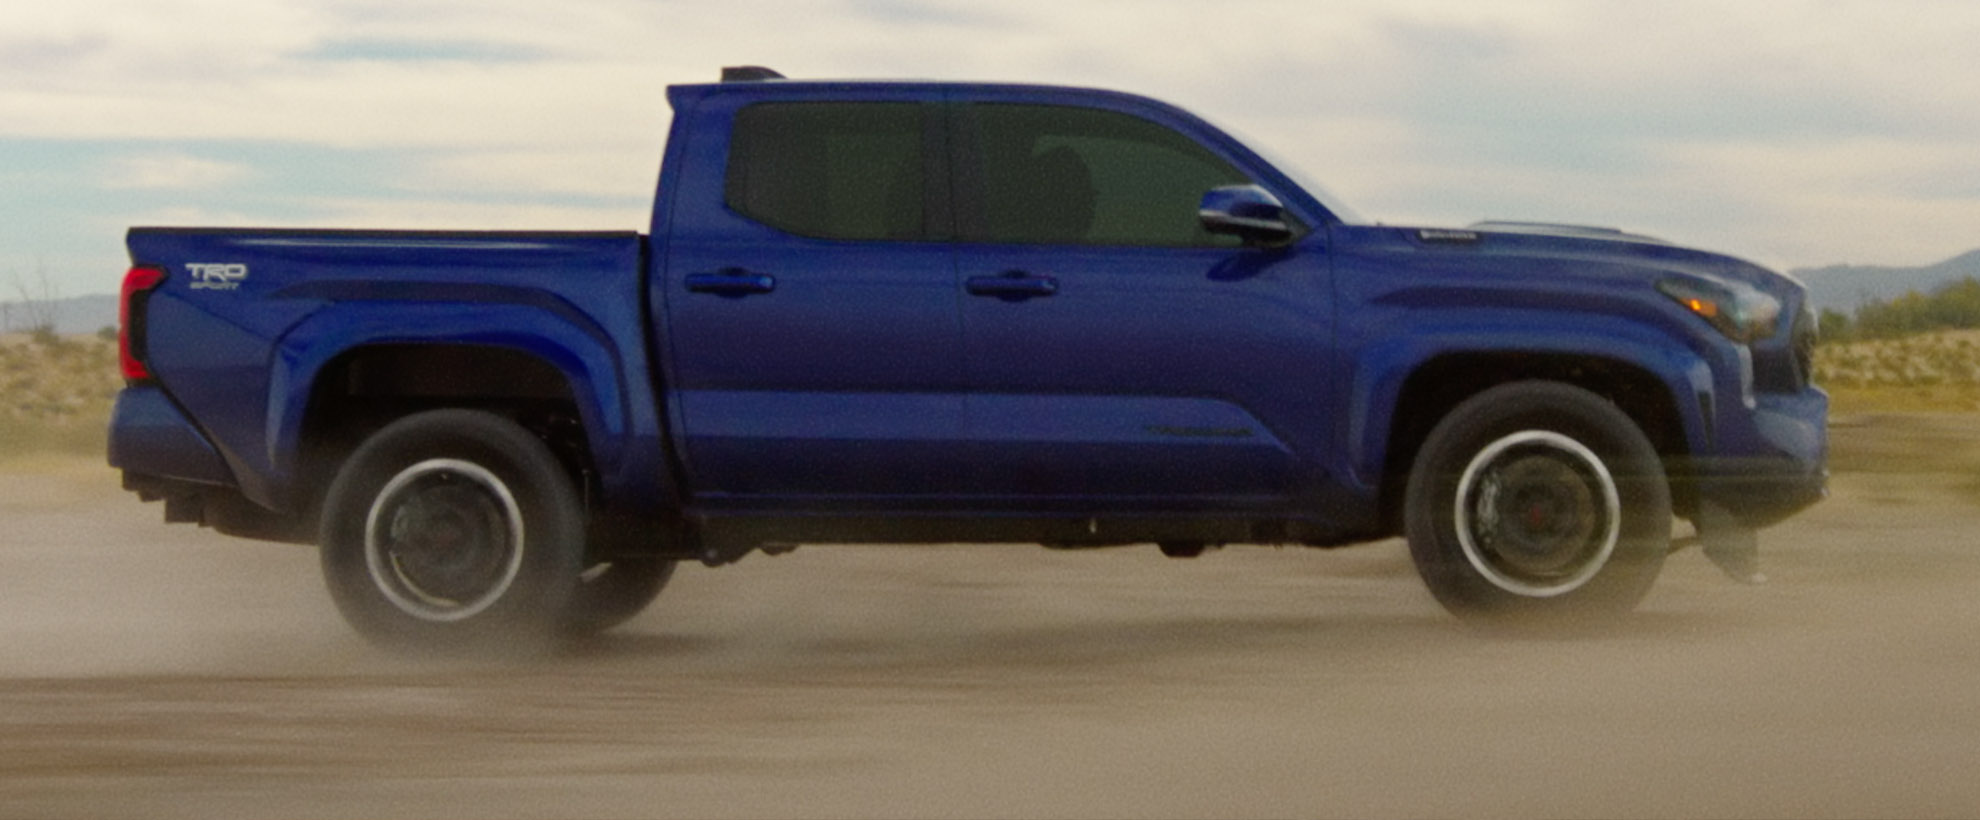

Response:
(0, 420), (1980, 818)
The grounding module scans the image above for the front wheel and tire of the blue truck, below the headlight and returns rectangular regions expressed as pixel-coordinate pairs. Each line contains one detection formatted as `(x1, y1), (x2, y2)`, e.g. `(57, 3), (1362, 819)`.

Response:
(1404, 382), (1671, 628)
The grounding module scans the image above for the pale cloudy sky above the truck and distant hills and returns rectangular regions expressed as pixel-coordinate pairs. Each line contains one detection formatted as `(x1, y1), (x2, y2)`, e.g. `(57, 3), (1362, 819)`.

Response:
(0, 0), (1980, 297)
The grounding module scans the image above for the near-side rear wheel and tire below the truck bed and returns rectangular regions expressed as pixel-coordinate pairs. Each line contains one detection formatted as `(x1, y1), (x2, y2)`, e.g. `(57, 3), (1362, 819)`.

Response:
(323, 410), (584, 654)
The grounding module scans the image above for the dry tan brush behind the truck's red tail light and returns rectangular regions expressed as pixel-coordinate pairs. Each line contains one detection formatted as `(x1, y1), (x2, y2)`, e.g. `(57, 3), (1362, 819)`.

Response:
(0, 333), (123, 458)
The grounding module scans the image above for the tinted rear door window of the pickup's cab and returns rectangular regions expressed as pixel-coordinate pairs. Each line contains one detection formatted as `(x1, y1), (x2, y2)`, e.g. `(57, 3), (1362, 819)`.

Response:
(725, 103), (925, 240)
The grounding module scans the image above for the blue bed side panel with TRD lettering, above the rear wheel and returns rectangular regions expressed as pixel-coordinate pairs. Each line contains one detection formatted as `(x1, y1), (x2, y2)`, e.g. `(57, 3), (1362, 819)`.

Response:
(131, 230), (663, 509)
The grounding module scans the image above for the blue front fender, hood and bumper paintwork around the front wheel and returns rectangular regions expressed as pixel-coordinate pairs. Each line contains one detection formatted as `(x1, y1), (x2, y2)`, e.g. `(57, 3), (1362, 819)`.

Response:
(1335, 226), (1826, 505)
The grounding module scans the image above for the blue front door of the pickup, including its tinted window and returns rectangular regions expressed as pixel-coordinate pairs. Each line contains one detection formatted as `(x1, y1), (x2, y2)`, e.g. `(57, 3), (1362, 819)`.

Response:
(952, 93), (1333, 509)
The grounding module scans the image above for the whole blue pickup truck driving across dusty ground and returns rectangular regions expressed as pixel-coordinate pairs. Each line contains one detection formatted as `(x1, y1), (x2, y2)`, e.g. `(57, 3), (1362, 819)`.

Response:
(109, 67), (1828, 648)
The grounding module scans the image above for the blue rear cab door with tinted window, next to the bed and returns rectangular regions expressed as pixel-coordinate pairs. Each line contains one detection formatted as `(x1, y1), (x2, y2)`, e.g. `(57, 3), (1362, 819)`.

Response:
(655, 85), (962, 499)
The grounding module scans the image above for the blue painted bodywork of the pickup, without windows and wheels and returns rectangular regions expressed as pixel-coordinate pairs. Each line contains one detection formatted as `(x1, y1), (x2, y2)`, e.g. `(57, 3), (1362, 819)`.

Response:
(113, 81), (1826, 535)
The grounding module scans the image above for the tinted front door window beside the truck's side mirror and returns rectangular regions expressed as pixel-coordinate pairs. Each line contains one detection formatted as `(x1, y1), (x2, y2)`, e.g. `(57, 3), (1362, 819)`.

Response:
(964, 105), (1251, 246)
